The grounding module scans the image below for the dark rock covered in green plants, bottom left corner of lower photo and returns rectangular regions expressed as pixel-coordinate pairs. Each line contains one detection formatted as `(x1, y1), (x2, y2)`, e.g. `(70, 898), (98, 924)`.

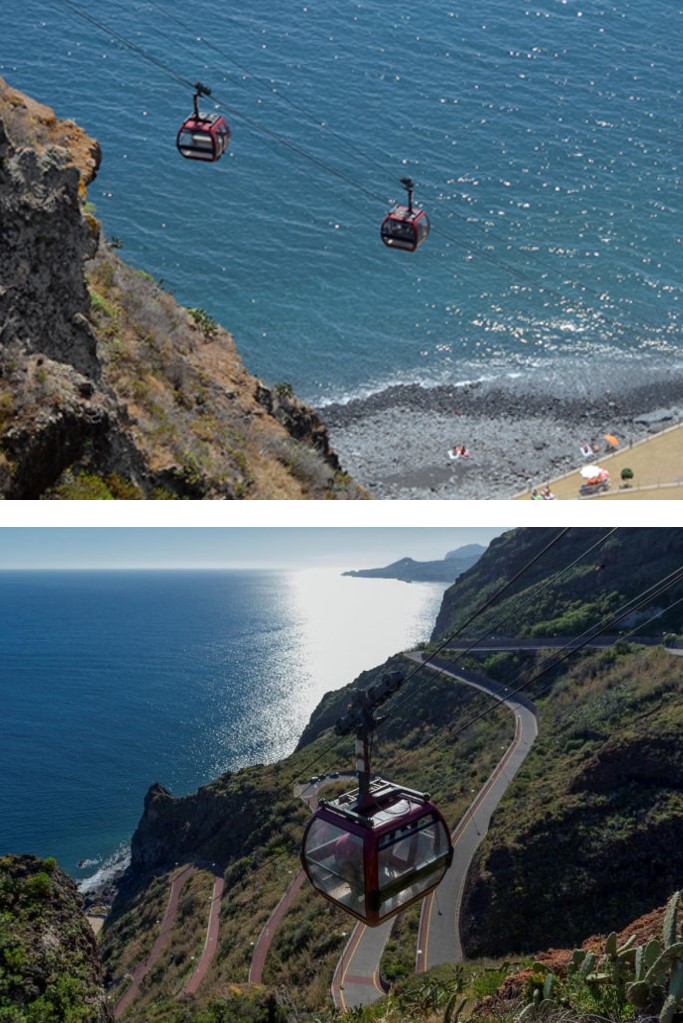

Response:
(0, 856), (113, 1023)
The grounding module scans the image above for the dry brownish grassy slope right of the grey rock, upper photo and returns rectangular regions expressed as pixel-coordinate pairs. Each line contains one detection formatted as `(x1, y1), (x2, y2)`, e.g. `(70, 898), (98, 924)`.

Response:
(88, 246), (362, 500)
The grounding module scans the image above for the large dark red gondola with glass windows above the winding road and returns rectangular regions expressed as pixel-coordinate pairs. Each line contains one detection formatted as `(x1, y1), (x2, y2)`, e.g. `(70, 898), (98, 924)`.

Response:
(302, 672), (453, 927)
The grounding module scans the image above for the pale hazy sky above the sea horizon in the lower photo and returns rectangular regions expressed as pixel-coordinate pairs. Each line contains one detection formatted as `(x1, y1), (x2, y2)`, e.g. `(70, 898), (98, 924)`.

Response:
(0, 526), (506, 570)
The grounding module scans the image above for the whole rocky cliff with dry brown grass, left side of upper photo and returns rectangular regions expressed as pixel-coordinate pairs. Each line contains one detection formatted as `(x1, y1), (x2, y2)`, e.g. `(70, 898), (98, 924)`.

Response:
(0, 79), (365, 499)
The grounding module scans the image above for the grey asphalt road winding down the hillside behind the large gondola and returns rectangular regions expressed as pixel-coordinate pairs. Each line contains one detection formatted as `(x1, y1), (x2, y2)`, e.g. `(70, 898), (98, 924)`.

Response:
(331, 652), (538, 1010)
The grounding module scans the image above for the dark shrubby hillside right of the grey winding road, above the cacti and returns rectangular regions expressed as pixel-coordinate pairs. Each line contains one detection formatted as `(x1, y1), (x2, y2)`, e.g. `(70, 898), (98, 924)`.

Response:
(453, 648), (683, 958)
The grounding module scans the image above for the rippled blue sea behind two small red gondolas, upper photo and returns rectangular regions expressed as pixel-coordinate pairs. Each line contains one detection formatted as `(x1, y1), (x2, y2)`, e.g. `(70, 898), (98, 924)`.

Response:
(0, 0), (683, 405)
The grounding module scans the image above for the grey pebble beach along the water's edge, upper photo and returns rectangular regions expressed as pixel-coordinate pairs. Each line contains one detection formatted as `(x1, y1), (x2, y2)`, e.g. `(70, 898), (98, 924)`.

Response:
(319, 373), (683, 500)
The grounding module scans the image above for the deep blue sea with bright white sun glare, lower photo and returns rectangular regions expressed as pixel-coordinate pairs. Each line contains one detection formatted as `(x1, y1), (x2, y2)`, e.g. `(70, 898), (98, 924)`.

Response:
(0, 570), (445, 883)
